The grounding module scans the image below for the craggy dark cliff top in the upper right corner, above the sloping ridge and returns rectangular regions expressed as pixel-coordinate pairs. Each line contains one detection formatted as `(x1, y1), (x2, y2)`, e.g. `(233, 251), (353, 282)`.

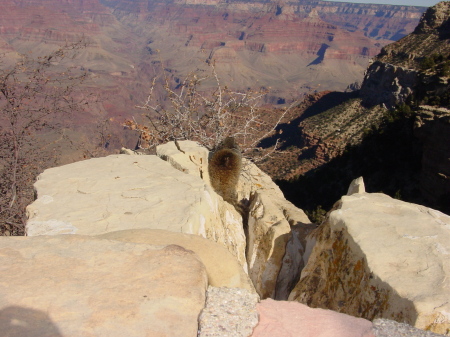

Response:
(361, 1), (450, 108)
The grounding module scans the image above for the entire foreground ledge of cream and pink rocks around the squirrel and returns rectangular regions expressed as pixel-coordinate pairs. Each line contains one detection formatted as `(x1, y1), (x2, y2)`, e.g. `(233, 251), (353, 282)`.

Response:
(0, 142), (450, 337)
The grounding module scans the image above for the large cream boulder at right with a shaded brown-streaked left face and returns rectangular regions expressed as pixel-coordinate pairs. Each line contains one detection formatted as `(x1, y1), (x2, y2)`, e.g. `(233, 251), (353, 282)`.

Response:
(289, 193), (450, 333)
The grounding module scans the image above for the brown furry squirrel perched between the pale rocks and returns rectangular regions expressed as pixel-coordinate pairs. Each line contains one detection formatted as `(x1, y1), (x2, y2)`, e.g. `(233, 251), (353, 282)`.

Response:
(208, 137), (242, 206)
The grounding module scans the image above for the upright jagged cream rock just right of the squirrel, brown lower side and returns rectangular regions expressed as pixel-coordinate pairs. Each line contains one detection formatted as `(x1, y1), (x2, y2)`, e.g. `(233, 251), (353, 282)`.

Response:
(243, 161), (313, 299)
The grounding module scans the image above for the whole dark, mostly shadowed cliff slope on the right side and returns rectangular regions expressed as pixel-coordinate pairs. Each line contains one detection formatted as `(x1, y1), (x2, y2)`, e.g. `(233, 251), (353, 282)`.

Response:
(265, 2), (450, 213)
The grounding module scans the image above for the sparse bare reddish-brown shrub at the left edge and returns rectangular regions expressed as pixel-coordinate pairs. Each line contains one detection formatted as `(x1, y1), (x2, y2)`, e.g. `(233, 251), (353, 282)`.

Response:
(0, 41), (86, 235)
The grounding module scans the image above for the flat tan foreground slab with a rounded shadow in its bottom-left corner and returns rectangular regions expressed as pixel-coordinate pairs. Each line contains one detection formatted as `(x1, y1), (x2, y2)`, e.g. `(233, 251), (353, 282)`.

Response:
(0, 235), (207, 337)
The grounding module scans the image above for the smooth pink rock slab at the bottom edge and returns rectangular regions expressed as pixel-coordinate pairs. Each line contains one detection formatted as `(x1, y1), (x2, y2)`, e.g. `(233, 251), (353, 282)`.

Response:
(252, 299), (374, 337)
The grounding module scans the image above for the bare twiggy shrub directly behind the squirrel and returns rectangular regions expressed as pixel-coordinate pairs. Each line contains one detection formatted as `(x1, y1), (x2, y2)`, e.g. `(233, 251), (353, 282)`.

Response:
(125, 64), (288, 158)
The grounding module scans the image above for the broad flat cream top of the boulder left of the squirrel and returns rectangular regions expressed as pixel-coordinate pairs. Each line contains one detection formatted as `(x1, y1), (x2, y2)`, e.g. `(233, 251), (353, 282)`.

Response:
(26, 155), (213, 236)
